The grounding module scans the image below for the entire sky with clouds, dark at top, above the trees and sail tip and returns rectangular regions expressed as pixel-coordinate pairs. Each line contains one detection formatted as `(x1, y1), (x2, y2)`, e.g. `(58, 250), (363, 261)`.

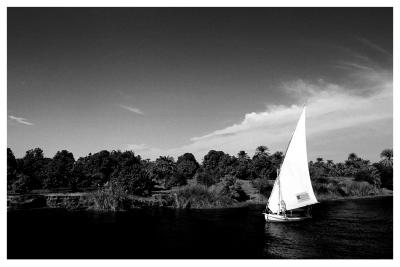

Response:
(7, 7), (393, 162)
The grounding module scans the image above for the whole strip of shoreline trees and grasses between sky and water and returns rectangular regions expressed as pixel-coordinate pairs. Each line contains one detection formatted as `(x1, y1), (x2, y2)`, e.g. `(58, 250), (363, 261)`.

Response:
(7, 146), (393, 211)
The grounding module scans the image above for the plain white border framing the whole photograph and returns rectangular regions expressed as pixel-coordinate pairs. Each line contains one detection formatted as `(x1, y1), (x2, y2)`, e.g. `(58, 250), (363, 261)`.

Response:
(0, 0), (400, 267)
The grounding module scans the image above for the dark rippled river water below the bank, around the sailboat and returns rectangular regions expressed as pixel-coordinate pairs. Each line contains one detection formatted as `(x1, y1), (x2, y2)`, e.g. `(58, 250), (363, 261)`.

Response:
(7, 197), (393, 259)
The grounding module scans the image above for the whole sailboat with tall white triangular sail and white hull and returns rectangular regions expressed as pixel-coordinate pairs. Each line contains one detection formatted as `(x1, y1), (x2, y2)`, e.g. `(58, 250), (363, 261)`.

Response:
(263, 107), (318, 222)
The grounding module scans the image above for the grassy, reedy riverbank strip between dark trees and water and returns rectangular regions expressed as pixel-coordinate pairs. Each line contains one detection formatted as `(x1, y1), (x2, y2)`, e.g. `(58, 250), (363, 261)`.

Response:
(7, 177), (393, 211)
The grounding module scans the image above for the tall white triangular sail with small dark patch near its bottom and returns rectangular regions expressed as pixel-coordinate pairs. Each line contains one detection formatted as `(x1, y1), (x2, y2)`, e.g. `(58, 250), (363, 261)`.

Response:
(268, 108), (318, 213)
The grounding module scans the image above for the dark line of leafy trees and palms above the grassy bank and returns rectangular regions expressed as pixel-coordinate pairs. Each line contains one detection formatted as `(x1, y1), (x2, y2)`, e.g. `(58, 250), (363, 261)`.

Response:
(7, 146), (393, 196)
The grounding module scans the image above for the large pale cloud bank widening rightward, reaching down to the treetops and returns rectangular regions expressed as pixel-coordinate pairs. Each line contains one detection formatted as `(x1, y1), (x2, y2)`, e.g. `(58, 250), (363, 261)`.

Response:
(126, 59), (393, 160)
